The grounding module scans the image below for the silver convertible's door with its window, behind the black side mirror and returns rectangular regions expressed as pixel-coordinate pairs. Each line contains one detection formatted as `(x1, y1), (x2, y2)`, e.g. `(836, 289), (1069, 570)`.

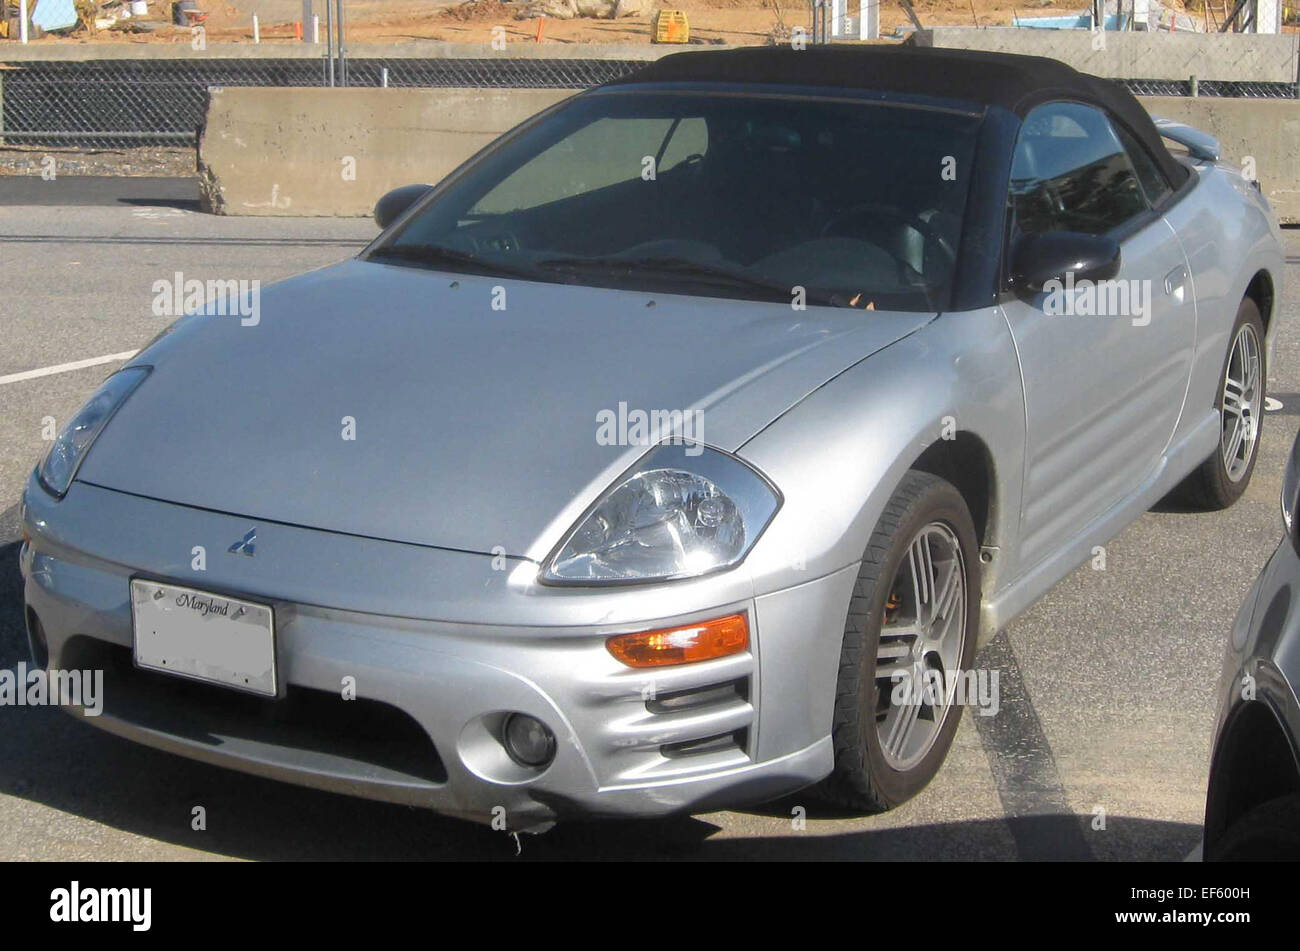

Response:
(1002, 101), (1196, 569)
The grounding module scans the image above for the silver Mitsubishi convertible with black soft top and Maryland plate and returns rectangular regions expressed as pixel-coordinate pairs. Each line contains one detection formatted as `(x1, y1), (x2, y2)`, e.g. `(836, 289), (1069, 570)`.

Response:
(21, 48), (1283, 830)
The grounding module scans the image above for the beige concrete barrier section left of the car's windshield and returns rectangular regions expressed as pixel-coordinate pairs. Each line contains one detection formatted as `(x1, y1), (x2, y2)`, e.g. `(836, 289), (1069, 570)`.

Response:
(199, 87), (573, 216)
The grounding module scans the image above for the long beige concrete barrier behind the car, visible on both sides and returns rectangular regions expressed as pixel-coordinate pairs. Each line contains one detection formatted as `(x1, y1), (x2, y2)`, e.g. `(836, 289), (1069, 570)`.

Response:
(199, 87), (1300, 222)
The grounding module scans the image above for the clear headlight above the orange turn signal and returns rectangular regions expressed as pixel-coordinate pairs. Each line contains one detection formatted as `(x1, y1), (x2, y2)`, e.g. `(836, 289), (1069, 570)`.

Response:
(542, 446), (780, 585)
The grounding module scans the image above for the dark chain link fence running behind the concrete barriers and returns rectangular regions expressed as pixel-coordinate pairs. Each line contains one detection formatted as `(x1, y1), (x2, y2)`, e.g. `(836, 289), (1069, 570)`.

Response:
(0, 53), (1297, 148)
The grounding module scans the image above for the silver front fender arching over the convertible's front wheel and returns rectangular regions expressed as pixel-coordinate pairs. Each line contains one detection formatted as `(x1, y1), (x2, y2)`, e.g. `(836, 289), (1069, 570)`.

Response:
(740, 308), (1024, 639)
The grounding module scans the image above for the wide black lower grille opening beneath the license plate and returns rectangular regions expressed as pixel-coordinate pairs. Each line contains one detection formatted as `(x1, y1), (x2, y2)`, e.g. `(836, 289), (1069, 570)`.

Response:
(60, 635), (447, 785)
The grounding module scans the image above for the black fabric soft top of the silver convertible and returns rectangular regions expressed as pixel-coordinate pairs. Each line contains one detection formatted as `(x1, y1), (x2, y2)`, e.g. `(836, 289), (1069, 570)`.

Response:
(607, 45), (1187, 187)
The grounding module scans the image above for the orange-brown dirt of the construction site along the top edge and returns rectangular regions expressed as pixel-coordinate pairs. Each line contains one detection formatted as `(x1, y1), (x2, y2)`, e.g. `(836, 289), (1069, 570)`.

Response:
(15, 0), (1263, 44)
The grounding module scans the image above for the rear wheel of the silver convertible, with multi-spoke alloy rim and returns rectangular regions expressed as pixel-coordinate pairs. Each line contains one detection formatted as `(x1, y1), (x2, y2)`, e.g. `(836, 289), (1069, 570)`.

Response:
(1179, 298), (1268, 511)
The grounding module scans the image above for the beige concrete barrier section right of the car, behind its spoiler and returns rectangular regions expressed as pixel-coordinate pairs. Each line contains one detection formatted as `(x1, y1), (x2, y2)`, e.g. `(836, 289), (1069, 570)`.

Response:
(1140, 96), (1300, 225)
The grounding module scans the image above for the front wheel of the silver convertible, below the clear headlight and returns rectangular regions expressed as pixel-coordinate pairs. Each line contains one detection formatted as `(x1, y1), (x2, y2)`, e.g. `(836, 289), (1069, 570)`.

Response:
(822, 472), (980, 812)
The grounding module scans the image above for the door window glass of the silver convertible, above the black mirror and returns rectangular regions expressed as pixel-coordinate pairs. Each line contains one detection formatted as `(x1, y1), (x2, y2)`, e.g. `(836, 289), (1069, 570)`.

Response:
(1010, 103), (1149, 234)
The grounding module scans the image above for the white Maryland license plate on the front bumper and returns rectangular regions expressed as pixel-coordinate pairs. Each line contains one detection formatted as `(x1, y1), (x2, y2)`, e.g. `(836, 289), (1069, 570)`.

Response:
(131, 579), (277, 696)
